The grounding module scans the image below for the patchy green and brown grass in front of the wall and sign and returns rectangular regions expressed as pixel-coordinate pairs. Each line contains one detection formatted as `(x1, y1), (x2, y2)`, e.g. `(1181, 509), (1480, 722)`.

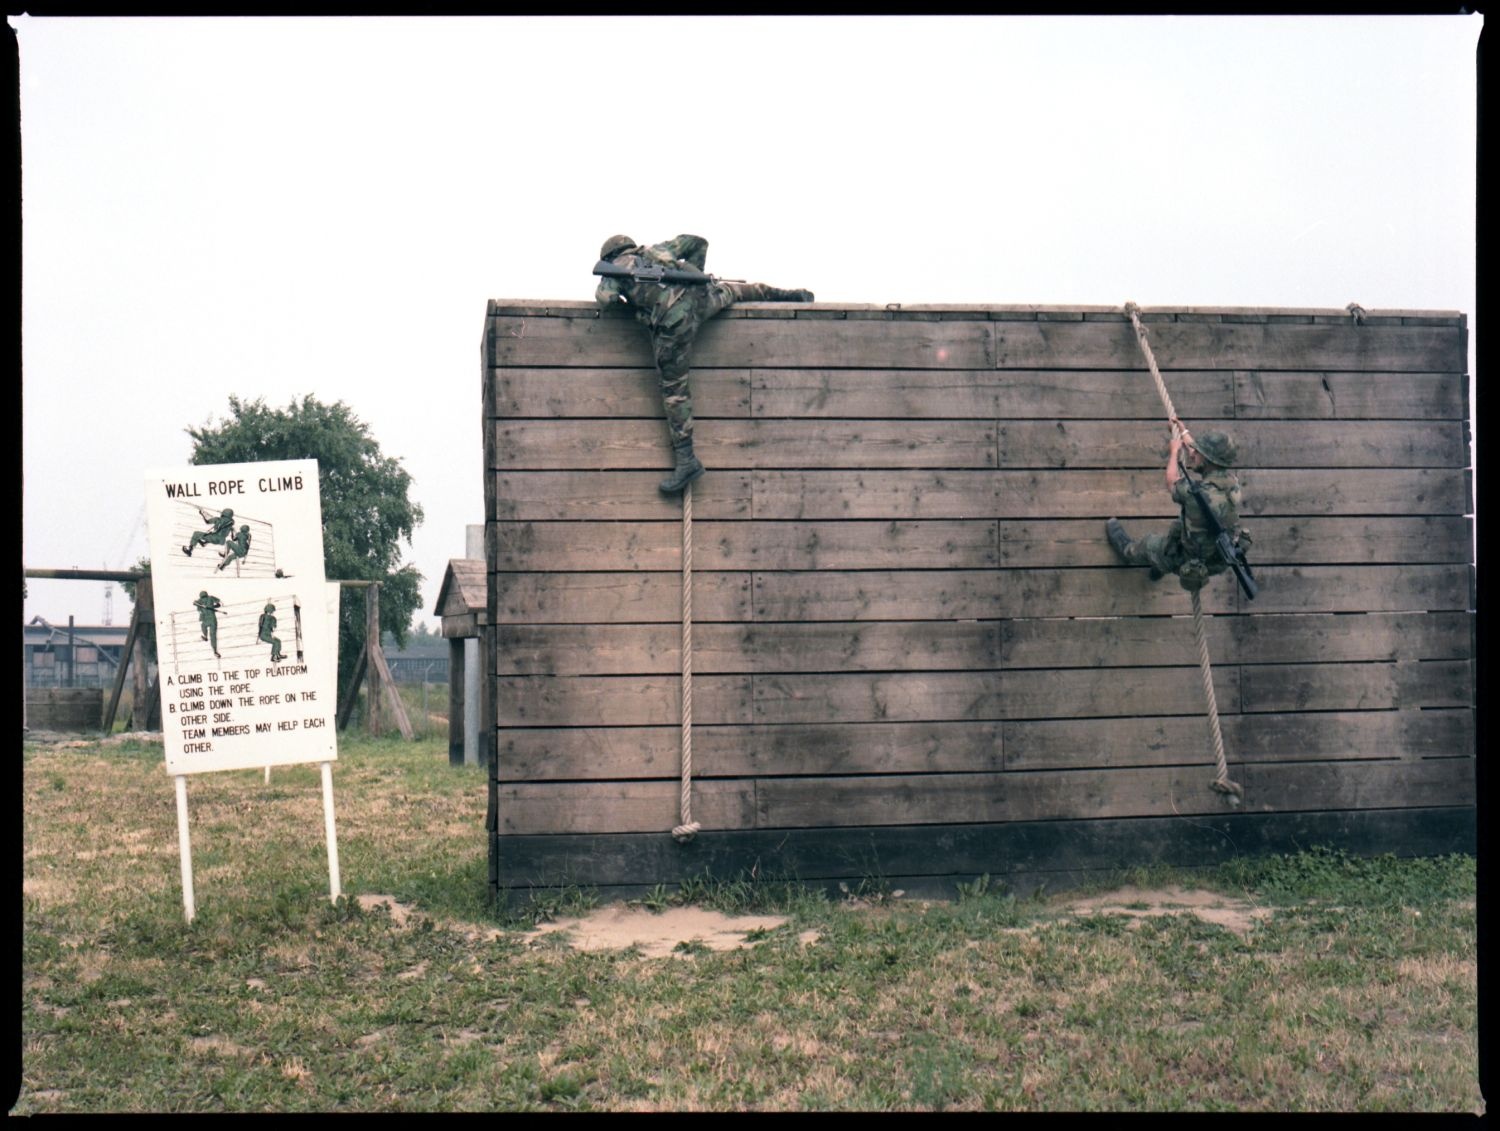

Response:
(12, 735), (1484, 1115)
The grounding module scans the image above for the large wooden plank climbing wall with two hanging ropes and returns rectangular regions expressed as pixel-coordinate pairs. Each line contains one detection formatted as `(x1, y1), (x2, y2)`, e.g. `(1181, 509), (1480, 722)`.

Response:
(482, 300), (1475, 894)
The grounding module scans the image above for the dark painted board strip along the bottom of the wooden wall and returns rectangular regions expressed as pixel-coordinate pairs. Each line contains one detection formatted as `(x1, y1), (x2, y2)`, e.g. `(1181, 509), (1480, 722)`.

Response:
(488, 807), (1476, 903)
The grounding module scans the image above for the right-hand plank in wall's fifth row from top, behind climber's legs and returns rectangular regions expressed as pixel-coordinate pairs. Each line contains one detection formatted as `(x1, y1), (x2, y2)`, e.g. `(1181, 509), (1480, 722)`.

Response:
(1002, 515), (1475, 570)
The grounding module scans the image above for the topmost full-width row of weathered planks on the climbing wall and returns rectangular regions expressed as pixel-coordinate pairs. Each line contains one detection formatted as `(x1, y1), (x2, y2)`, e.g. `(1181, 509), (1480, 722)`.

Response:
(486, 315), (1467, 372)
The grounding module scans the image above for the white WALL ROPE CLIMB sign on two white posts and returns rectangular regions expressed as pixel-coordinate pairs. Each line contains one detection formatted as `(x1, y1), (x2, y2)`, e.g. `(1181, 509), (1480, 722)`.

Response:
(146, 459), (341, 923)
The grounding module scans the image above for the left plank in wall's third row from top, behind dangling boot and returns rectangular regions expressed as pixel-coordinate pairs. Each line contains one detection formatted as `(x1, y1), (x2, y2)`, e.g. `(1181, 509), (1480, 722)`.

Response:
(494, 420), (996, 471)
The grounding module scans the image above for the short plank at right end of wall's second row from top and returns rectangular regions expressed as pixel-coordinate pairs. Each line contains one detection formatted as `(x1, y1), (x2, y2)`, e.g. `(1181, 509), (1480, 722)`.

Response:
(1236, 370), (1469, 420)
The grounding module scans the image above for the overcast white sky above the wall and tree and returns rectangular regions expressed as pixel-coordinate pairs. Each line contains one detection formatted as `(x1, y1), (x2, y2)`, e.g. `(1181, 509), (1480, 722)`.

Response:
(11, 15), (1482, 626)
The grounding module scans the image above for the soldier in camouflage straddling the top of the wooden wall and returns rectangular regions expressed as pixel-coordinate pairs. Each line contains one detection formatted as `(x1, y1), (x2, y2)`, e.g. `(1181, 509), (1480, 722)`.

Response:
(594, 236), (813, 495)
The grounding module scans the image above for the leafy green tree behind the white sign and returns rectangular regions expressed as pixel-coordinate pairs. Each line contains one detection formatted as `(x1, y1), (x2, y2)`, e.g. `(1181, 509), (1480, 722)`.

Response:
(188, 396), (422, 701)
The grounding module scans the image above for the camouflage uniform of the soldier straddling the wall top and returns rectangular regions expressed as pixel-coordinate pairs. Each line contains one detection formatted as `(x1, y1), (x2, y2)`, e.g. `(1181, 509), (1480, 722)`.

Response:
(594, 236), (813, 444)
